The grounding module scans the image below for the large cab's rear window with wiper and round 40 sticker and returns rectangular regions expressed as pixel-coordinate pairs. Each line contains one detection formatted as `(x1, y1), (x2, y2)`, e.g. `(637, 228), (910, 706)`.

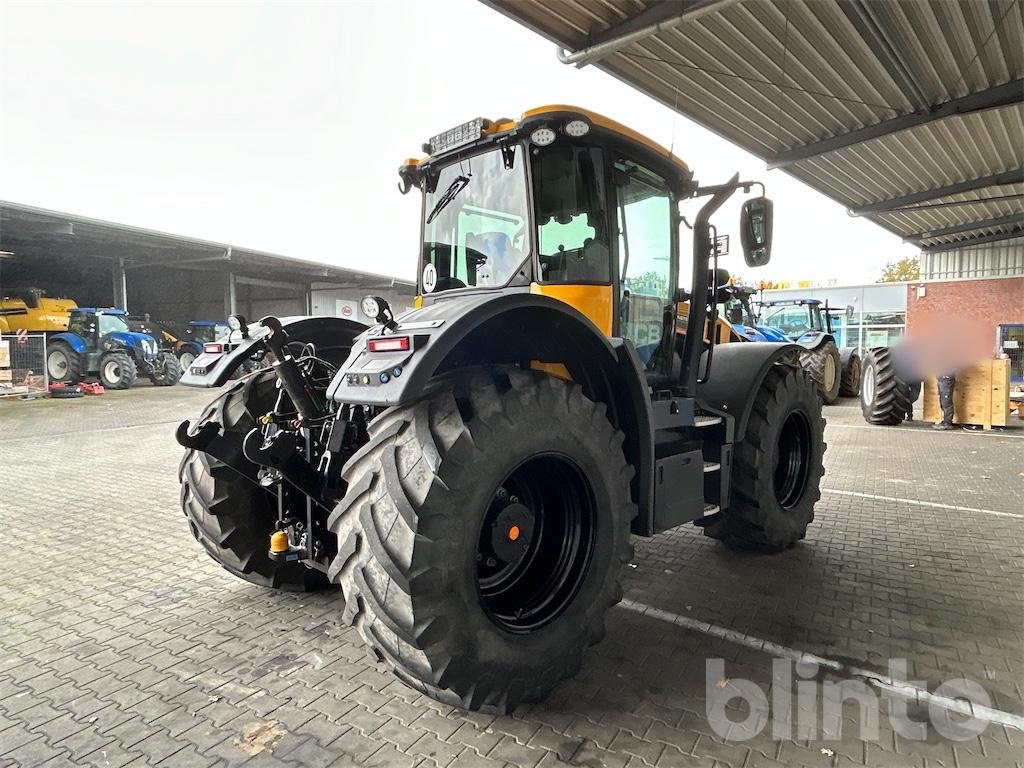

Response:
(421, 148), (529, 293)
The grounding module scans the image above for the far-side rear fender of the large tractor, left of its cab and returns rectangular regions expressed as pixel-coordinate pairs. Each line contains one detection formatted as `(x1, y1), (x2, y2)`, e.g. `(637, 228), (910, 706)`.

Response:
(180, 316), (367, 387)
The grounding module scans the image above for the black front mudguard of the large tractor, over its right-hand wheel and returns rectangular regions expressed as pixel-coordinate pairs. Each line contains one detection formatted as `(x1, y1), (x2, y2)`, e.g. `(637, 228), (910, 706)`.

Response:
(697, 341), (804, 442)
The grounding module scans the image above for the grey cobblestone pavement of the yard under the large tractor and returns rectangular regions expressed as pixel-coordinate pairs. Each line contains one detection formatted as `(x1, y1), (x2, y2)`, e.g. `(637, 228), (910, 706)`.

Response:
(0, 387), (1024, 768)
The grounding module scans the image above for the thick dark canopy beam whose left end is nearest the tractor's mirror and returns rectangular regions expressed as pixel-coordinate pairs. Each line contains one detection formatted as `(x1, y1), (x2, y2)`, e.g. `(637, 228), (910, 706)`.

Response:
(770, 79), (1024, 170)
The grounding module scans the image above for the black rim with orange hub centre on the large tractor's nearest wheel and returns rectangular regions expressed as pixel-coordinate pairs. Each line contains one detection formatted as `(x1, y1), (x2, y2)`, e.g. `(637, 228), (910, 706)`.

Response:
(476, 454), (597, 634)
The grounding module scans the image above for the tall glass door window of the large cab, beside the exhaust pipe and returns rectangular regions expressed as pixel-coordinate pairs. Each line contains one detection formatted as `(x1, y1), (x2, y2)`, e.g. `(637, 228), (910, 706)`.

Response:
(614, 161), (672, 362)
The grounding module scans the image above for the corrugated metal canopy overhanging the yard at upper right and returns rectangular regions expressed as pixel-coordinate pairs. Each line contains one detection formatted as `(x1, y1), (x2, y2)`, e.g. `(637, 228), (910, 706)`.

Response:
(482, 0), (1024, 250)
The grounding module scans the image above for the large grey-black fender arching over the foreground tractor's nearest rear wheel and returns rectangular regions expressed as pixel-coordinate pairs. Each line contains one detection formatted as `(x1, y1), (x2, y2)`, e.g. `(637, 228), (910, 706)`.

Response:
(328, 292), (654, 532)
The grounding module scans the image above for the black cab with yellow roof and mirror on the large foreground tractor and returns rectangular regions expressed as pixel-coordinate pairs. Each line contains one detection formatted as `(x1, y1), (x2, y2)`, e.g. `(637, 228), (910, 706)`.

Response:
(399, 105), (771, 389)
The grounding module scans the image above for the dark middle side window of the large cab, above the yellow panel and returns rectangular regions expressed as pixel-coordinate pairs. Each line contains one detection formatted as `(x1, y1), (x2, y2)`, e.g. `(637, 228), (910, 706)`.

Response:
(530, 141), (611, 284)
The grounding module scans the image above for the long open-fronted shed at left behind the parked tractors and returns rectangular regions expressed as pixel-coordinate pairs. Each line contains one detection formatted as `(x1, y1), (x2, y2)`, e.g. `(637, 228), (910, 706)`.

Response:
(0, 202), (416, 323)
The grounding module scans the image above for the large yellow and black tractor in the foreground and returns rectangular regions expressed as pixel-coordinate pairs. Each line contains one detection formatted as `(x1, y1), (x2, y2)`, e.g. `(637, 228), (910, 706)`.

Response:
(177, 105), (825, 711)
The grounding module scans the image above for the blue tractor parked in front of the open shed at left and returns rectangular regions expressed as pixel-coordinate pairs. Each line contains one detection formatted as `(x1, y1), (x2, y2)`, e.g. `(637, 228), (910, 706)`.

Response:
(46, 307), (181, 389)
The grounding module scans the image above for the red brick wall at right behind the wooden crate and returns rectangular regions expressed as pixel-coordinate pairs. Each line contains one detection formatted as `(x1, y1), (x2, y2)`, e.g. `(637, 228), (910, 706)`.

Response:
(906, 276), (1024, 346)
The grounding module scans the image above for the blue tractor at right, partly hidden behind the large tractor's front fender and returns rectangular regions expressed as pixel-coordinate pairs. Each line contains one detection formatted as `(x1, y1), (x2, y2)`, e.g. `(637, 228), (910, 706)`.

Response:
(757, 299), (860, 404)
